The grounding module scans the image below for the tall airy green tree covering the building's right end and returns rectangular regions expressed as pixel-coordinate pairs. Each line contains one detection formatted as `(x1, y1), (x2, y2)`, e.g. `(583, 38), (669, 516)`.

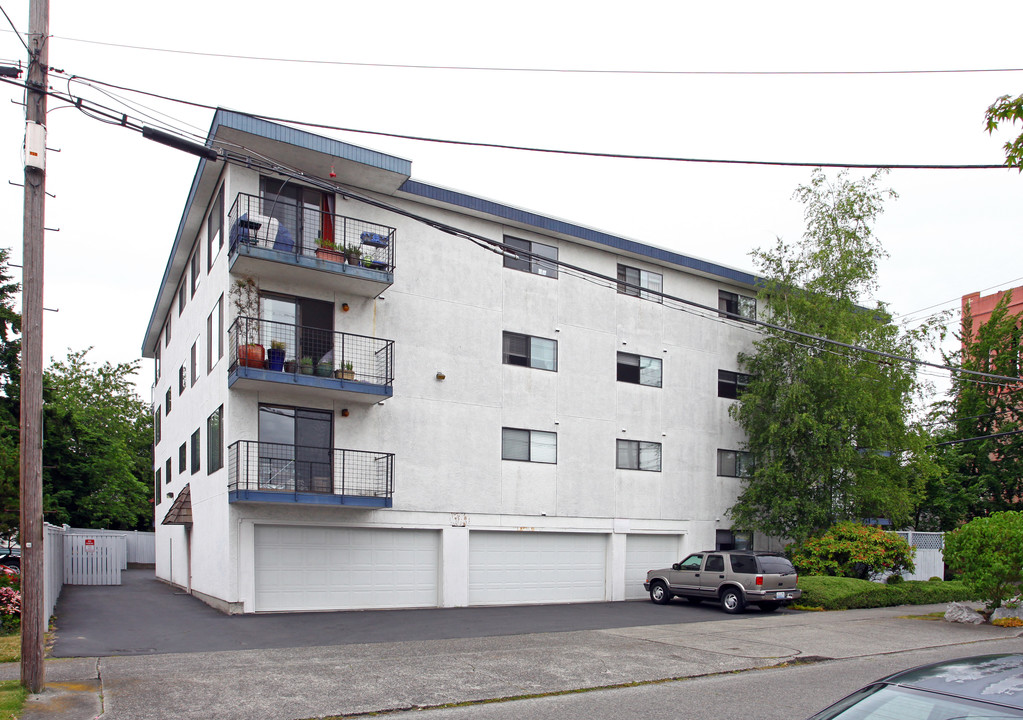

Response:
(729, 170), (927, 542)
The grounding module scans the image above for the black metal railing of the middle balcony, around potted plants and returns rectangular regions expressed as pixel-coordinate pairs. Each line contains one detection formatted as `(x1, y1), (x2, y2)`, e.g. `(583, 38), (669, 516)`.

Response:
(227, 317), (394, 387)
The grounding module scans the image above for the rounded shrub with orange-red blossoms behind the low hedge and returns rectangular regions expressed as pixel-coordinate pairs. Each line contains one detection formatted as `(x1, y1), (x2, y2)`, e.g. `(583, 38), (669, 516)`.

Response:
(787, 522), (915, 580)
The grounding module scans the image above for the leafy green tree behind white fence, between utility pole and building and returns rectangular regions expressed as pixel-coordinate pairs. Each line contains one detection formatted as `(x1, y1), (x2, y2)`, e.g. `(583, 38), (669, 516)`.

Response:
(43, 350), (153, 530)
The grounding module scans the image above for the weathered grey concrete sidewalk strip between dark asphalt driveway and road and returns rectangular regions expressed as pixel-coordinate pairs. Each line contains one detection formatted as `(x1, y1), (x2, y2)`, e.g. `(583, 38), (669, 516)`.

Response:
(0, 605), (1021, 720)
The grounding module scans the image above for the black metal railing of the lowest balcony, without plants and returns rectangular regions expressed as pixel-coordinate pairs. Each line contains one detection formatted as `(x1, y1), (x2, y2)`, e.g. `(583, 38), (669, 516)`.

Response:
(227, 440), (394, 498)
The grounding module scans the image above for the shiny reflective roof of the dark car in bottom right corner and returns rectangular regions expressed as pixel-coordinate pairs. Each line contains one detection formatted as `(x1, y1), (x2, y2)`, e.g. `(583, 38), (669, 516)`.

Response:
(880, 654), (1023, 709)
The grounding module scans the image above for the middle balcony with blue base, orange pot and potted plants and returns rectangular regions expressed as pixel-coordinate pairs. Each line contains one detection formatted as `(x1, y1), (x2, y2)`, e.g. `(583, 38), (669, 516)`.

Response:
(227, 317), (394, 403)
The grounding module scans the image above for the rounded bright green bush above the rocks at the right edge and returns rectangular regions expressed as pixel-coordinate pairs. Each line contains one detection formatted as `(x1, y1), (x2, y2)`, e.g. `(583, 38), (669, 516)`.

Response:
(944, 511), (1023, 616)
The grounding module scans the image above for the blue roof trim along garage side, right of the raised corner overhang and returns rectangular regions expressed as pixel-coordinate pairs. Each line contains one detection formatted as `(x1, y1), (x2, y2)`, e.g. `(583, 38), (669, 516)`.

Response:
(398, 179), (760, 285)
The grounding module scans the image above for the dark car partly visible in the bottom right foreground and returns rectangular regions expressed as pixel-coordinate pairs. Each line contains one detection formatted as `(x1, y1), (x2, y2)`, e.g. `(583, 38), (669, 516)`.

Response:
(810, 655), (1023, 720)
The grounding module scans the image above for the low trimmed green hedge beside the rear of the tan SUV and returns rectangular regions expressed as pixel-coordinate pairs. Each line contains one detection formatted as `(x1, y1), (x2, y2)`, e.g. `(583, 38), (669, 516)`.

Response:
(799, 575), (979, 610)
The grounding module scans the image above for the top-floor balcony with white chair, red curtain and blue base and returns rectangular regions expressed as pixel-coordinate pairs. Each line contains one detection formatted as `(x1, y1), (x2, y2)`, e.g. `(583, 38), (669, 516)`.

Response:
(228, 193), (395, 298)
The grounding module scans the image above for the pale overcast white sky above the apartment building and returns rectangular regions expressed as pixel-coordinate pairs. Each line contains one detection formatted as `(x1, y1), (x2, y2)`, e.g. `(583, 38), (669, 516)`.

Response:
(0, 0), (1023, 401)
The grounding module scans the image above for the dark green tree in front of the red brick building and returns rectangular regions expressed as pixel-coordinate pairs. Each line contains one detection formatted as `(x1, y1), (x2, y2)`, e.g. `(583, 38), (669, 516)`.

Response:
(937, 293), (1023, 519)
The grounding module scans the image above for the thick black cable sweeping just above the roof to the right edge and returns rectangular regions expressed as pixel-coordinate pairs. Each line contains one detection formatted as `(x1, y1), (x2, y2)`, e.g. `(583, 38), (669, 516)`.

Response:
(48, 70), (1007, 170)
